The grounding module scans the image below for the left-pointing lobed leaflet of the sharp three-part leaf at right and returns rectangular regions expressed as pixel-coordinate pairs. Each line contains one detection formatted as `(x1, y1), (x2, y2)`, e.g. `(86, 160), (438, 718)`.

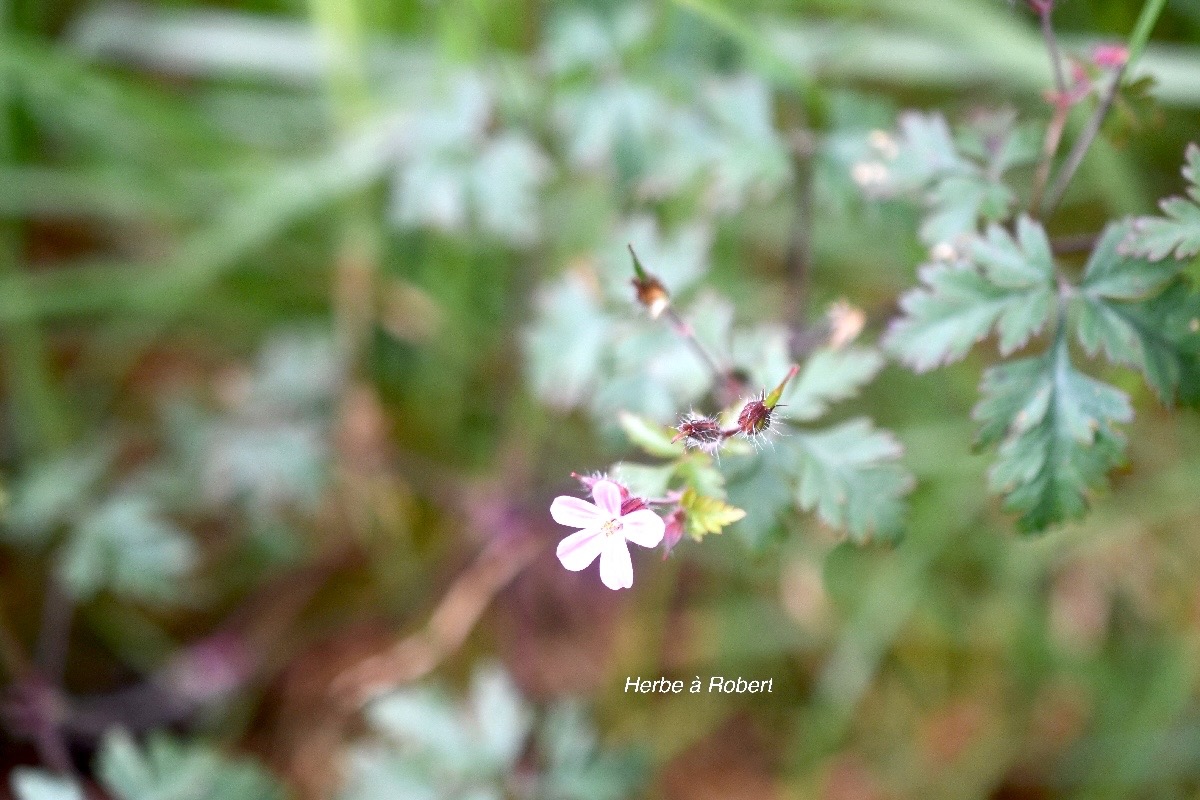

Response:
(883, 264), (1054, 372)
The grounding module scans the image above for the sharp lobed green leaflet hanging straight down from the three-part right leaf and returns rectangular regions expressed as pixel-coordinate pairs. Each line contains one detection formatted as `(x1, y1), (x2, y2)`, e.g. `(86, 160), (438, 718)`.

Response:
(974, 336), (1133, 531)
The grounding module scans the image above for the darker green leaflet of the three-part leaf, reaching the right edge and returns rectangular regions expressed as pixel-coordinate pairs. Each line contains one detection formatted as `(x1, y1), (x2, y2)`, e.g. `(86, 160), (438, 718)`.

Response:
(1074, 278), (1200, 404)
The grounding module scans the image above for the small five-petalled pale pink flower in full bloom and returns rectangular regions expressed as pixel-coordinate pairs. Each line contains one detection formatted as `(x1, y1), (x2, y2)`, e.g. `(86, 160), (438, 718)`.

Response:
(550, 481), (666, 589)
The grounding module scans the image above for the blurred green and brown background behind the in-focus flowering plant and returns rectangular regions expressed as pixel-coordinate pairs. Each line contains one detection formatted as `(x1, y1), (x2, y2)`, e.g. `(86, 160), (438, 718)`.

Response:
(0, 0), (1200, 800)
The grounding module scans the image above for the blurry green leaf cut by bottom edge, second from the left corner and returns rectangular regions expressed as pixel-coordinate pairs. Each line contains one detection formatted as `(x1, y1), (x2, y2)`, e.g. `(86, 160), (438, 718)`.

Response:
(96, 730), (284, 800)
